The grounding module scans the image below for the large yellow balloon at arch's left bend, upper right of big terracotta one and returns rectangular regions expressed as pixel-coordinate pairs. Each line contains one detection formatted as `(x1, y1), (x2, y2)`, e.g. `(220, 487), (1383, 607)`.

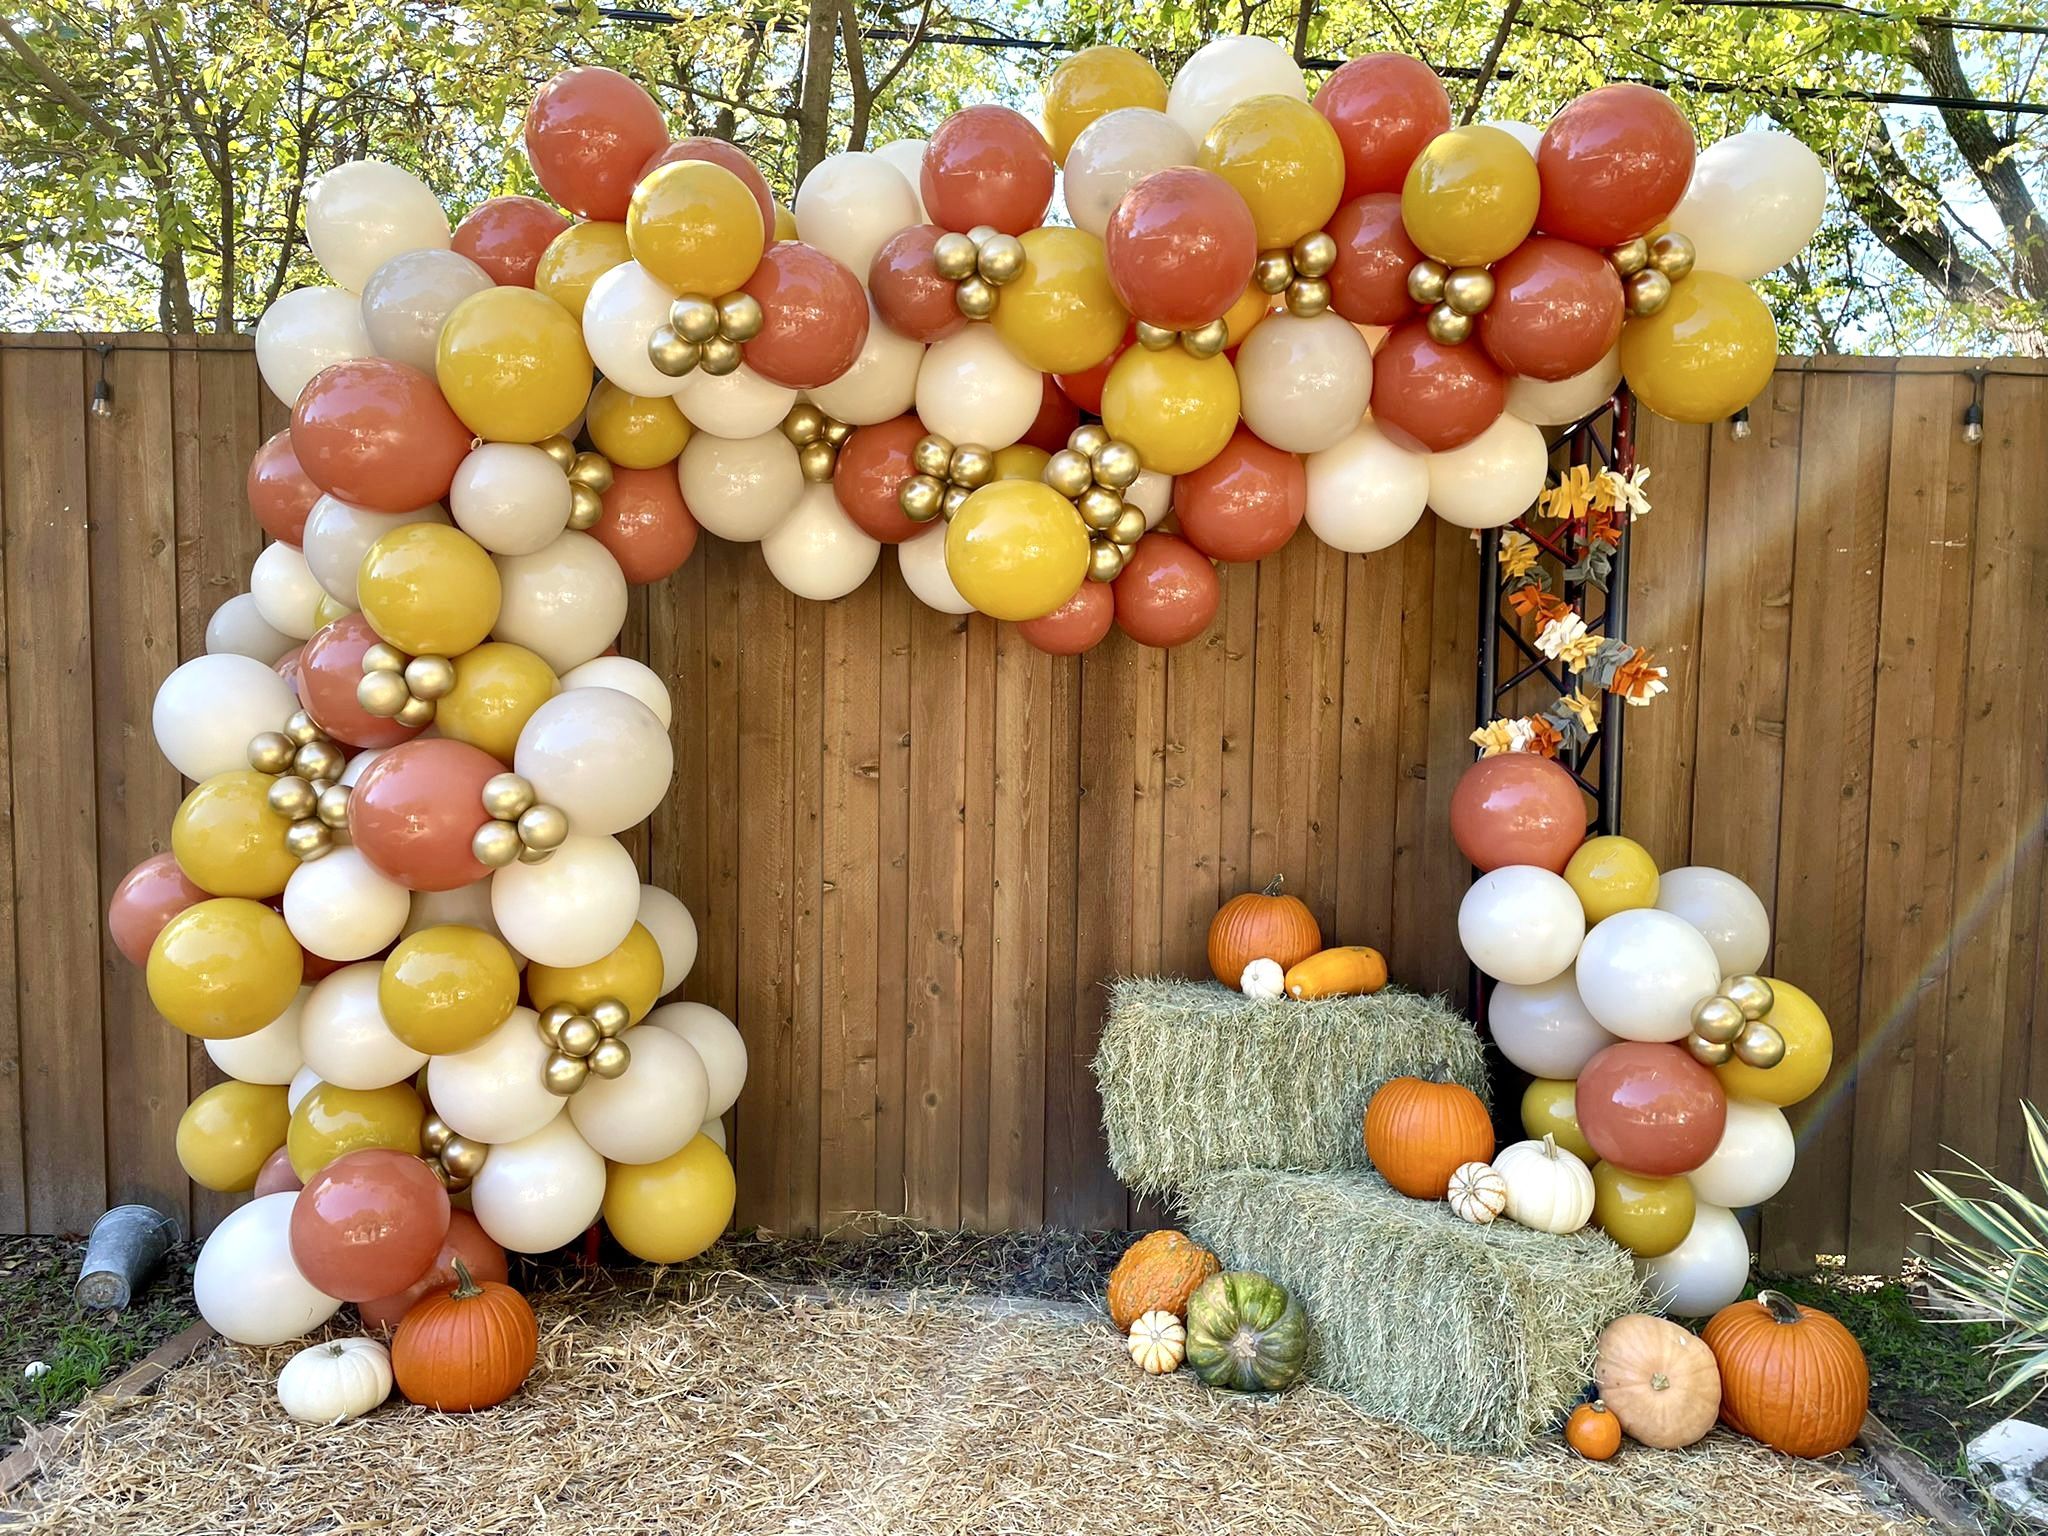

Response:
(434, 287), (590, 442)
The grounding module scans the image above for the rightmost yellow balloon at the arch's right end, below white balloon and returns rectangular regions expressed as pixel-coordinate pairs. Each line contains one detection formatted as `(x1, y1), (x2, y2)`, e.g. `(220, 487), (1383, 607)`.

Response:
(1622, 272), (1778, 422)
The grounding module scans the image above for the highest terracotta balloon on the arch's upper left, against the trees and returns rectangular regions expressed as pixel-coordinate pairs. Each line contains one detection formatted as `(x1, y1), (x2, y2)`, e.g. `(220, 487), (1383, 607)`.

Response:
(526, 70), (668, 219)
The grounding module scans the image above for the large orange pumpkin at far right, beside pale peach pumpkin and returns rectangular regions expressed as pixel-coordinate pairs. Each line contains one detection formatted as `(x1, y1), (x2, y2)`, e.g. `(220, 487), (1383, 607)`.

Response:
(1700, 1290), (1870, 1456)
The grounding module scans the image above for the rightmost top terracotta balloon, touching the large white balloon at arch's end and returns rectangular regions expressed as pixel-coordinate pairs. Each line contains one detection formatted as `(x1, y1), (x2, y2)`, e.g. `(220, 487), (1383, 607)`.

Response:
(1536, 84), (1696, 246)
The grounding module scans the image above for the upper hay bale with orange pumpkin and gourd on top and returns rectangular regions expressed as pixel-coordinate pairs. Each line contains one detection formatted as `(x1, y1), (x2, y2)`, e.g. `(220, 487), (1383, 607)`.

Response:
(1094, 977), (1487, 1194)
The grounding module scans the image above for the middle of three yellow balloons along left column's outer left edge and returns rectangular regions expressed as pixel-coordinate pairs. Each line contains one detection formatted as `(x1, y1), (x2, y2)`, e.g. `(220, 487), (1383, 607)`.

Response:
(143, 897), (305, 1040)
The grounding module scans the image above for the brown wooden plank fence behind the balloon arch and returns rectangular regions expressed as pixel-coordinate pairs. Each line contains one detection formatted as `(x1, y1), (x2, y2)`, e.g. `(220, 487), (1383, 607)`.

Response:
(0, 336), (2048, 1268)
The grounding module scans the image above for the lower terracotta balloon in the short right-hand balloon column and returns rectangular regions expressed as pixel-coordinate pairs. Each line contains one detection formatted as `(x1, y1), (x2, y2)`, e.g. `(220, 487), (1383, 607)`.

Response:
(1577, 1040), (1729, 1178)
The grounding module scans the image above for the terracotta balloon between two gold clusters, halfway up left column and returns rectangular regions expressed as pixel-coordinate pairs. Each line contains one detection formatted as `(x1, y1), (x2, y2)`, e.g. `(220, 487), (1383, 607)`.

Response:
(348, 737), (504, 891)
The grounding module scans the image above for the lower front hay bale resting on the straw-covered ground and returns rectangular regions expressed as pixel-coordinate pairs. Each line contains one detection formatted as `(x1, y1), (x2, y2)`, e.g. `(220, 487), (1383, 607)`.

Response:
(1180, 1169), (1638, 1450)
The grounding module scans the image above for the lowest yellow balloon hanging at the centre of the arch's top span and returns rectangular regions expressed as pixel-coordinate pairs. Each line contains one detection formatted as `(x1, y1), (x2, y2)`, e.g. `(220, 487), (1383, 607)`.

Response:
(946, 479), (1087, 623)
